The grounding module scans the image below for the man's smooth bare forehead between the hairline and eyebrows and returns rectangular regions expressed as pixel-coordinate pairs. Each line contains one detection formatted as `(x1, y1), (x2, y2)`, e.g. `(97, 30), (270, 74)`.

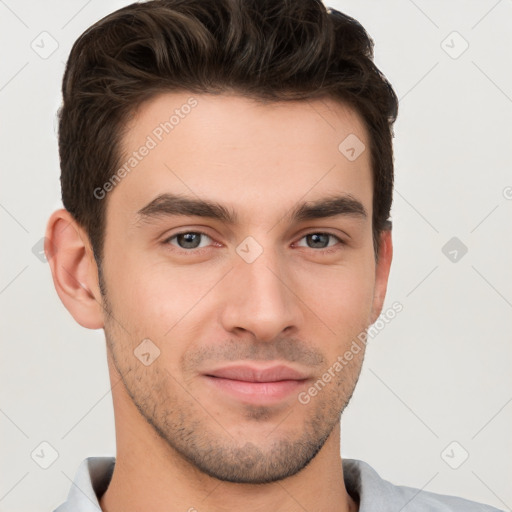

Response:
(109, 92), (372, 224)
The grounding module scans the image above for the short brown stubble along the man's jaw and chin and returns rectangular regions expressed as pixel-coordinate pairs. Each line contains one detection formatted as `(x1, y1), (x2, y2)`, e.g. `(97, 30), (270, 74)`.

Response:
(100, 272), (364, 484)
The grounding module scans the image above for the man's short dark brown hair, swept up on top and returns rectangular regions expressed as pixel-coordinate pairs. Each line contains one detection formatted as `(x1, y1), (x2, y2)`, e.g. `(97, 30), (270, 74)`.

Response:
(59, 0), (398, 265)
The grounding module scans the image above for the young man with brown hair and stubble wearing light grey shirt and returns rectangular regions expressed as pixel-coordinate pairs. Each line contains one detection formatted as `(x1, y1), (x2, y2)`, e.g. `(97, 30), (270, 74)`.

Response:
(46, 0), (504, 512)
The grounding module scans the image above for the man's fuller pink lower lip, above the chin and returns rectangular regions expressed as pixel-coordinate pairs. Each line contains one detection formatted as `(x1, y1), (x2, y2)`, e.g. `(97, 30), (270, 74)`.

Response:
(206, 375), (305, 403)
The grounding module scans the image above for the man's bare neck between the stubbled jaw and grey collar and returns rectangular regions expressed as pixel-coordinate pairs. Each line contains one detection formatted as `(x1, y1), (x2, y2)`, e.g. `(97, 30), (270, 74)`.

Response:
(100, 406), (358, 512)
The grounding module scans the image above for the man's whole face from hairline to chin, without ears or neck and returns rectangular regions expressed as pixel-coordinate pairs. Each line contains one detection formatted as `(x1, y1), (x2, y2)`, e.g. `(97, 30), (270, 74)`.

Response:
(98, 93), (387, 483)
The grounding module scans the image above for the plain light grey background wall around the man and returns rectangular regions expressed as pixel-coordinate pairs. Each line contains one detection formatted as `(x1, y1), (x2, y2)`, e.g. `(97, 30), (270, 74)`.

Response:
(0, 0), (512, 512)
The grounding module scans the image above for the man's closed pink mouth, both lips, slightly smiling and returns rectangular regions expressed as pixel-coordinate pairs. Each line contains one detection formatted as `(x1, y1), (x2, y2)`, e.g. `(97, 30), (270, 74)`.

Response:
(203, 365), (310, 405)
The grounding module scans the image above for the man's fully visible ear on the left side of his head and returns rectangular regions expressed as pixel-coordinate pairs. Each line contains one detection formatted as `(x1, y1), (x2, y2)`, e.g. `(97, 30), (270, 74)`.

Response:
(44, 209), (104, 329)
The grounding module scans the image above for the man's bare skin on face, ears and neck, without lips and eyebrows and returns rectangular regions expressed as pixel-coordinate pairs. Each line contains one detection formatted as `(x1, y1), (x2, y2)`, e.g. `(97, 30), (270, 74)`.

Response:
(46, 92), (392, 512)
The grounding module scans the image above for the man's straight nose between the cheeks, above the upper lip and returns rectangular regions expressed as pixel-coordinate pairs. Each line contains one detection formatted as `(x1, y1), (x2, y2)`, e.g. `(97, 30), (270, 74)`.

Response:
(221, 246), (302, 341)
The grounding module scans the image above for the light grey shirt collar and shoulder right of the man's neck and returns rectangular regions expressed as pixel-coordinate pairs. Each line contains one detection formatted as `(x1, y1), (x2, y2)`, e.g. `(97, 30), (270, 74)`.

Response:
(343, 459), (503, 512)
